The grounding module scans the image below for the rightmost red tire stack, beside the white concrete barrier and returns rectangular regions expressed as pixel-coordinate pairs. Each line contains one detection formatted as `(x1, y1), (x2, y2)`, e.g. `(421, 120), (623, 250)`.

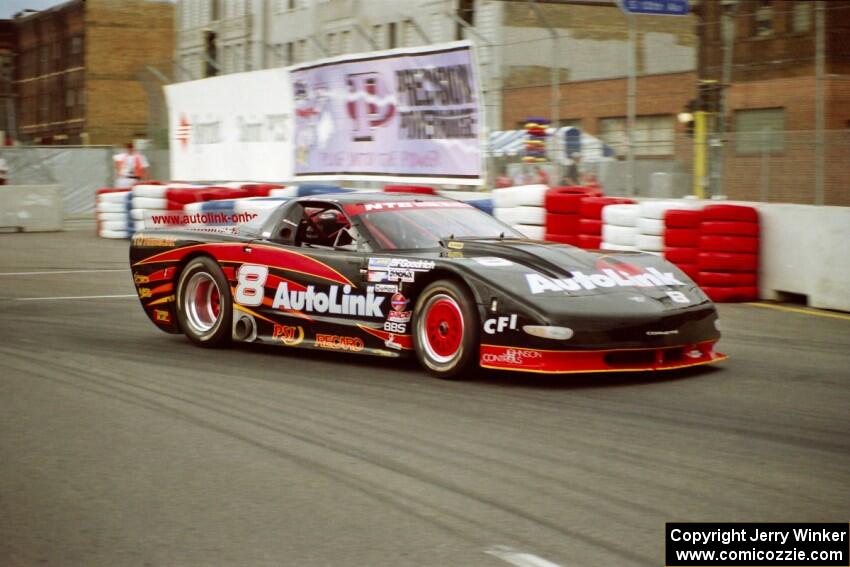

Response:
(697, 205), (759, 302)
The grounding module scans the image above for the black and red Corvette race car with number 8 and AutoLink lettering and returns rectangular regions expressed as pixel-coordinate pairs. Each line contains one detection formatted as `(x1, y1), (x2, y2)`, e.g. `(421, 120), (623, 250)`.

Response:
(130, 192), (725, 378)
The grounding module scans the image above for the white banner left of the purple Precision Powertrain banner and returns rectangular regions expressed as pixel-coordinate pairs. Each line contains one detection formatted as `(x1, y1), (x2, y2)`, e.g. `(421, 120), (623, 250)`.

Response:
(165, 69), (294, 181)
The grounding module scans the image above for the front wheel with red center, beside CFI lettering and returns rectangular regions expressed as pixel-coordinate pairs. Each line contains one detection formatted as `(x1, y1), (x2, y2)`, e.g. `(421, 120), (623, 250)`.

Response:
(413, 280), (480, 380)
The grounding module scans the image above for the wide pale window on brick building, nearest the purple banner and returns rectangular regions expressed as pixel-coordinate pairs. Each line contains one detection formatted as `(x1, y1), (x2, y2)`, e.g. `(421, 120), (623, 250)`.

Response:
(599, 114), (676, 156)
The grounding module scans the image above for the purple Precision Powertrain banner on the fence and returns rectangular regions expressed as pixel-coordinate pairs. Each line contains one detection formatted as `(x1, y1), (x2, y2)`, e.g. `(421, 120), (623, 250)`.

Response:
(290, 42), (483, 189)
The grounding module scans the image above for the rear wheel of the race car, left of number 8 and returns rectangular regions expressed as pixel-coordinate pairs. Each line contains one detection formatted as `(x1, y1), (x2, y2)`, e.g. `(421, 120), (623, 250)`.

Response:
(177, 256), (233, 347)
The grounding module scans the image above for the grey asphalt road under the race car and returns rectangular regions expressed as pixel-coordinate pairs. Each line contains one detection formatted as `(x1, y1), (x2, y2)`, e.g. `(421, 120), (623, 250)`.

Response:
(0, 230), (850, 567)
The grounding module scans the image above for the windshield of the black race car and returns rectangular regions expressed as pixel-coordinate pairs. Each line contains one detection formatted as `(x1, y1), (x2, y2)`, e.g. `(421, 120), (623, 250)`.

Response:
(351, 201), (523, 250)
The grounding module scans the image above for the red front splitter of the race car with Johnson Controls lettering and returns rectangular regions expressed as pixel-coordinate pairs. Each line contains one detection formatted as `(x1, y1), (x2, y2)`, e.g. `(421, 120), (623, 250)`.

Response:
(479, 340), (728, 374)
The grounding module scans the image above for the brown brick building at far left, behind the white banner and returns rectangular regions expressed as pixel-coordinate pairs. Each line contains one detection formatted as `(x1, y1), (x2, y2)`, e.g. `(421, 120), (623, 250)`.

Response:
(13, 0), (174, 145)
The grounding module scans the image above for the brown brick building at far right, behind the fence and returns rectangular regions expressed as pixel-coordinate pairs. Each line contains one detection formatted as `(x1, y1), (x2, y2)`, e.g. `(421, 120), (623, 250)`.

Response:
(697, 0), (850, 205)
